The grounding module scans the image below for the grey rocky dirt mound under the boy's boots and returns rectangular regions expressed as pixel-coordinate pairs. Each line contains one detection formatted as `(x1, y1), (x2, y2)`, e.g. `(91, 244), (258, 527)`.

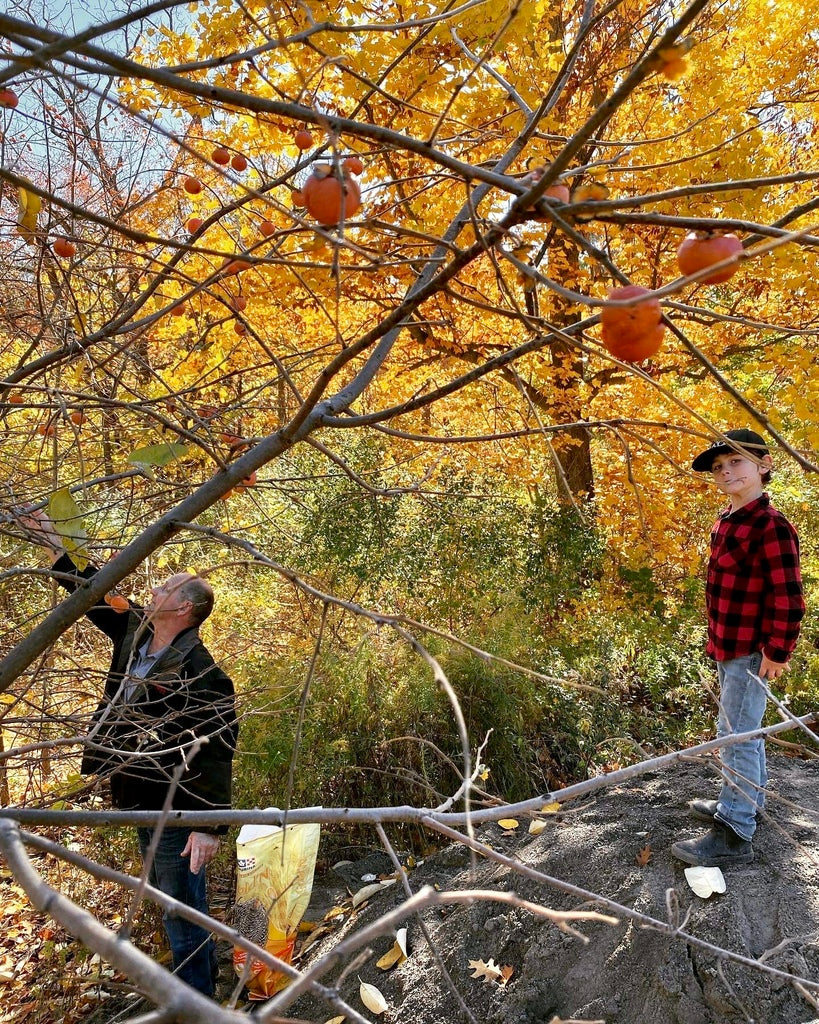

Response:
(290, 757), (819, 1024)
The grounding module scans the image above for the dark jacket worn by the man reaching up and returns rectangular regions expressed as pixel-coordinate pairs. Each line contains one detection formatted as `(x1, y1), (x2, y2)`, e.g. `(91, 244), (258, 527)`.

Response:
(53, 555), (238, 833)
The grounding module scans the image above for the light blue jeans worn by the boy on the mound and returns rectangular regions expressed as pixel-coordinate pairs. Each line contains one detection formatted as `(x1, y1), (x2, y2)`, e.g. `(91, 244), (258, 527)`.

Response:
(717, 652), (768, 840)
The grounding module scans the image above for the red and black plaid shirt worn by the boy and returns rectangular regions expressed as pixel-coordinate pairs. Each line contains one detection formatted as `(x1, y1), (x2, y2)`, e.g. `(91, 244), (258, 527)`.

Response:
(705, 495), (805, 663)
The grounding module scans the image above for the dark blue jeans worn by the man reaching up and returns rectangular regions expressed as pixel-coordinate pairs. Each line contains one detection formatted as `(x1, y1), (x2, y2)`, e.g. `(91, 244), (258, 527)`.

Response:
(136, 828), (218, 996)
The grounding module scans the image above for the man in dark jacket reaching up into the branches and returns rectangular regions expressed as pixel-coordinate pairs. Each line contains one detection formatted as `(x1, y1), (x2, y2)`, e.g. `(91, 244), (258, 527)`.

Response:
(23, 512), (236, 995)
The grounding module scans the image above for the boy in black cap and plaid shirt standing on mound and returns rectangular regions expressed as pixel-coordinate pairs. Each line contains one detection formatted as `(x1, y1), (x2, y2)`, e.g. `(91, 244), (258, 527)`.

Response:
(672, 429), (805, 867)
